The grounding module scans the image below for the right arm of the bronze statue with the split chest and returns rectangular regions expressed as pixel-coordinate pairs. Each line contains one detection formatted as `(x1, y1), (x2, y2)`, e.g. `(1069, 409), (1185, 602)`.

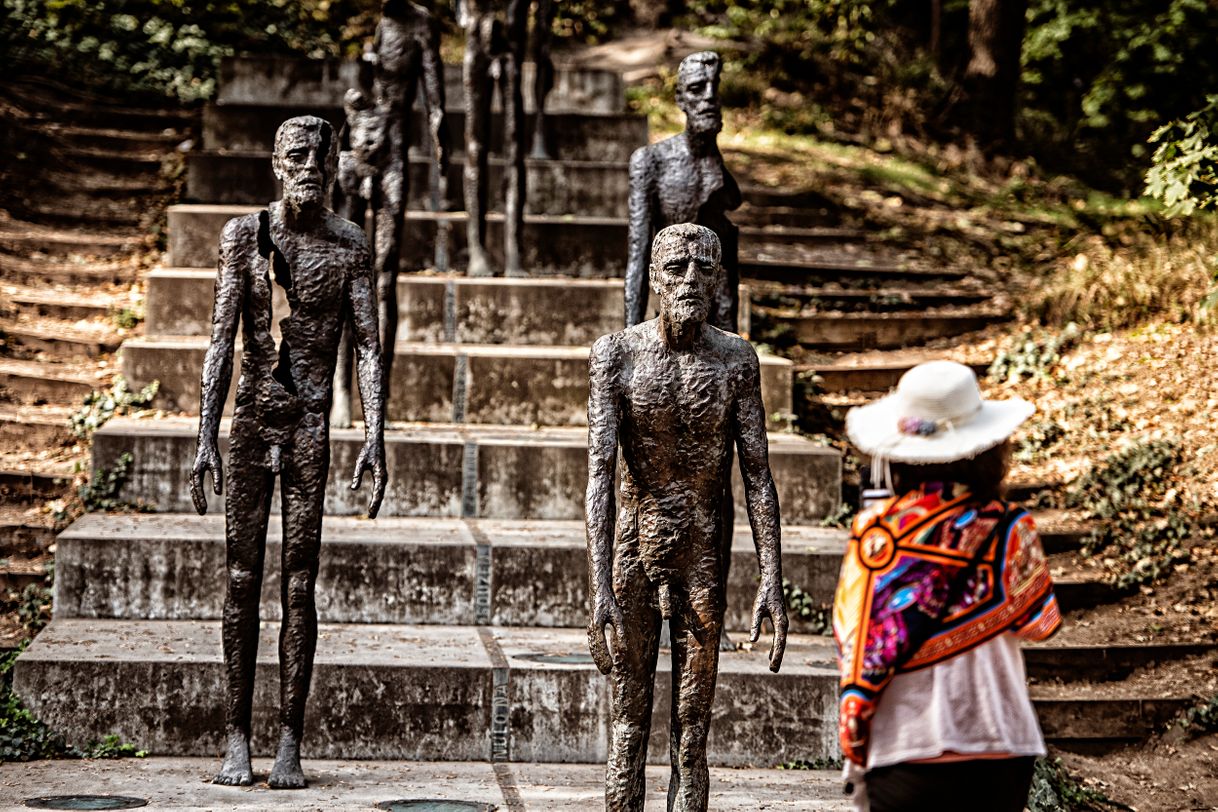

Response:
(347, 233), (386, 519)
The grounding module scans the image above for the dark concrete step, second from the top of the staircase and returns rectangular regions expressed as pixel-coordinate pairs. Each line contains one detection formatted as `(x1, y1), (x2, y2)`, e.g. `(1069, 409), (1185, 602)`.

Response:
(203, 103), (647, 161)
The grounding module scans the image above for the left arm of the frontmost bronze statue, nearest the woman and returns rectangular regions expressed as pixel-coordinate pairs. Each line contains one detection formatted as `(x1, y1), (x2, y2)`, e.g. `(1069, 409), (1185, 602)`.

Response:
(583, 336), (624, 673)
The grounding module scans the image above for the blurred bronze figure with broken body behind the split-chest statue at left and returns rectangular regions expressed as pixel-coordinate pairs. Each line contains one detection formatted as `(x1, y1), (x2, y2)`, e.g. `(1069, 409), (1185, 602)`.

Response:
(331, 0), (448, 427)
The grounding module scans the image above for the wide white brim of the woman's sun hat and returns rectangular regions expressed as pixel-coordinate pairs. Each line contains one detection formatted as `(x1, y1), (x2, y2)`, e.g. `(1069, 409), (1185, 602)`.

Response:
(845, 394), (1037, 465)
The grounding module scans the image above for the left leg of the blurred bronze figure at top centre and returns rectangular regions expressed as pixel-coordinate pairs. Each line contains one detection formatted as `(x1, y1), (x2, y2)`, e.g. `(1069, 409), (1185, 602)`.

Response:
(463, 32), (495, 276)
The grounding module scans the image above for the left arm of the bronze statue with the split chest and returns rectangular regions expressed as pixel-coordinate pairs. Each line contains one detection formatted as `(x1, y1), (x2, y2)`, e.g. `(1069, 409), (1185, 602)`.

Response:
(190, 219), (246, 515)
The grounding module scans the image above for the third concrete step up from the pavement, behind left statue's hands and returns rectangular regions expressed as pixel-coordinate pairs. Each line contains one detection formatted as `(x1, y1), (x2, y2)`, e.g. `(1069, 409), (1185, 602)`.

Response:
(93, 418), (842, 525)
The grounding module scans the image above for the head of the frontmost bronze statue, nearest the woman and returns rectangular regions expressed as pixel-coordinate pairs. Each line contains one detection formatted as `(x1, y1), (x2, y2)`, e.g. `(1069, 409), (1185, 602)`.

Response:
(652, 223), (722, 324)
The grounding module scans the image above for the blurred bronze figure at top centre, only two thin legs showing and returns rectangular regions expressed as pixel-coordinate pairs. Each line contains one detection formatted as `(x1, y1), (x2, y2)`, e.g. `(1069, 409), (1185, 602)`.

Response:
(459, 0), (529, 276)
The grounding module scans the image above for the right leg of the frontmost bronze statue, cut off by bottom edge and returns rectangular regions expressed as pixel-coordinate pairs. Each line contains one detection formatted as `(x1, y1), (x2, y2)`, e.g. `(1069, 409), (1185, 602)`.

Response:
(669, 569), (723, 812)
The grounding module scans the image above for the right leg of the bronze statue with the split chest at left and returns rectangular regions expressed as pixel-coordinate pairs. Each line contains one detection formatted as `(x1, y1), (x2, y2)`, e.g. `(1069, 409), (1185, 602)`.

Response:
(267, 414), (330, 789)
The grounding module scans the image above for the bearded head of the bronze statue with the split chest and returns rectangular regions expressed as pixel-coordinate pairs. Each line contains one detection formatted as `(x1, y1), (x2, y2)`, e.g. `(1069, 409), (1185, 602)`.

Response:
(270, 116), (339, 209)
